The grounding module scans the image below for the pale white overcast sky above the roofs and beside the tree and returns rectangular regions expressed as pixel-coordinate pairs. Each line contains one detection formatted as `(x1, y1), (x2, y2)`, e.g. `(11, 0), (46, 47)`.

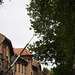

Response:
(0, 0), (55, 69)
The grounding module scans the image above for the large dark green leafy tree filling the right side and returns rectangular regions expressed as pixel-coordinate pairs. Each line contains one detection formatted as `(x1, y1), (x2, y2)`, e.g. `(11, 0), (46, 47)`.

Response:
(27, 0), (75, 75)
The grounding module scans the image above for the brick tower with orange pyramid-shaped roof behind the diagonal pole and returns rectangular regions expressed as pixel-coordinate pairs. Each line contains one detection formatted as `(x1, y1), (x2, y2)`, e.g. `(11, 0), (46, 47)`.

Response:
(14, 48), (33, 75)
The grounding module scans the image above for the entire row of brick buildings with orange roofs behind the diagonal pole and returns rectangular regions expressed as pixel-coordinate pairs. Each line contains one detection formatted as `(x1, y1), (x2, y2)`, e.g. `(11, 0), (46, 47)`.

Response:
(0, 33), (41, 75)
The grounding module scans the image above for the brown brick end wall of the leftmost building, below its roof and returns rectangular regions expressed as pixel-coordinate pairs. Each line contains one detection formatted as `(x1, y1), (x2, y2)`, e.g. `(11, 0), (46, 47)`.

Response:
(0, 42), (10, 75)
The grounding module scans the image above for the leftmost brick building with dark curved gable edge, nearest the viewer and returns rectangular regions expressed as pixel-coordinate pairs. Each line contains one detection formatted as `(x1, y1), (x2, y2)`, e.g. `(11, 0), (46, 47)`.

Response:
(0, 33), (14, 75)
